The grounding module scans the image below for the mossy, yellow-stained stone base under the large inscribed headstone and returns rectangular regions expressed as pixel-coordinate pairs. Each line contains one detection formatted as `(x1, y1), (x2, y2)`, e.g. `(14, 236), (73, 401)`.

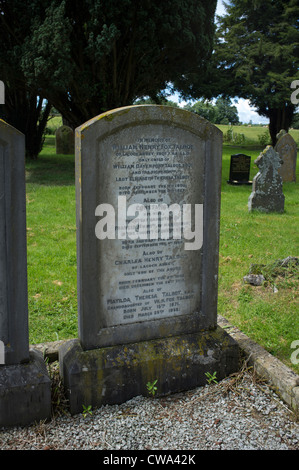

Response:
(59, 327), (239, 414)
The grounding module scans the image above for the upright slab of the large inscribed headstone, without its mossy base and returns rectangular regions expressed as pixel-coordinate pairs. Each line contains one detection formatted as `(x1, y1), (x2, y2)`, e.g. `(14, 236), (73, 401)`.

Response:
(76, 106), (222, 349)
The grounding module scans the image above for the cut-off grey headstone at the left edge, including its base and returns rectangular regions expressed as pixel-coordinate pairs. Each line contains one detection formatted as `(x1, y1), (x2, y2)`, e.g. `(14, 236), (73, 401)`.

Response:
(0, 120), (51, 427)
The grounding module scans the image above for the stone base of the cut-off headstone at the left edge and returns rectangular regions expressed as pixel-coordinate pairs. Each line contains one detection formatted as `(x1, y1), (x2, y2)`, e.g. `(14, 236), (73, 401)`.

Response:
(0, 350), (51, 428)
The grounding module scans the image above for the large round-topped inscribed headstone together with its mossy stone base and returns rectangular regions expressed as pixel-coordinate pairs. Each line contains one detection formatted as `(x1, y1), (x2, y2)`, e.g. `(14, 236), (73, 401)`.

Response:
(59, 106), (238, 413)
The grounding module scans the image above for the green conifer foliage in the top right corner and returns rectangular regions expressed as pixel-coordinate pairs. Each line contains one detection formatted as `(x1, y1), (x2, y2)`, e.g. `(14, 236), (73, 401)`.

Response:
(205, 0), (299, 144)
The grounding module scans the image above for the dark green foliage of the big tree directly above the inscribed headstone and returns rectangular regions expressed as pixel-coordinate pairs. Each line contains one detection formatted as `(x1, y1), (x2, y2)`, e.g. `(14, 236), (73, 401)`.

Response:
(21, 0), (216, 127)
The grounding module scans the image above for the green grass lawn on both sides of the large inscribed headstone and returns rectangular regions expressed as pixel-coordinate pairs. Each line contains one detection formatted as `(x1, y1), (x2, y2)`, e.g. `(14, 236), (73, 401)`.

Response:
(26, 126), (299, 373)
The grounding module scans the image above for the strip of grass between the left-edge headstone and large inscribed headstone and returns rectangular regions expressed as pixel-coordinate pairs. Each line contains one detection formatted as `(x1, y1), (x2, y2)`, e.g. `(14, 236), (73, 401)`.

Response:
(26, 136), (77, 343)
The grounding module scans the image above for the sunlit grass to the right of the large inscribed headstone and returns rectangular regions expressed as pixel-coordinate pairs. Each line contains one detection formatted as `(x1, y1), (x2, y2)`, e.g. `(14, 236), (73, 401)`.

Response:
(218, 147), (299, 372)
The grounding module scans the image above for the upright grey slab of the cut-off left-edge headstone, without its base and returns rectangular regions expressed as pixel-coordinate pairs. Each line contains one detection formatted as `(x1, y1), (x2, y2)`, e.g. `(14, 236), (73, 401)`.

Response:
(0, 120), (29, 365)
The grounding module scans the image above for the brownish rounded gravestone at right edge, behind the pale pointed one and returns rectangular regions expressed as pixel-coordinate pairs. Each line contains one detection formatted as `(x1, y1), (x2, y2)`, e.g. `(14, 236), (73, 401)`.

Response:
(274, 129), (297, 182)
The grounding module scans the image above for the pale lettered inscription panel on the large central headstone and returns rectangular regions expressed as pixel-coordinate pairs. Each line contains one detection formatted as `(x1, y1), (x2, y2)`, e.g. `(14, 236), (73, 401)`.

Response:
(95, 126), (204, 326)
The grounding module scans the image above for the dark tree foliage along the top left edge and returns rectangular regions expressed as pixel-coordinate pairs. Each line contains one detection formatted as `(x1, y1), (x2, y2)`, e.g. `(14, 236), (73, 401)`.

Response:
(0, 0), (51, 158)
